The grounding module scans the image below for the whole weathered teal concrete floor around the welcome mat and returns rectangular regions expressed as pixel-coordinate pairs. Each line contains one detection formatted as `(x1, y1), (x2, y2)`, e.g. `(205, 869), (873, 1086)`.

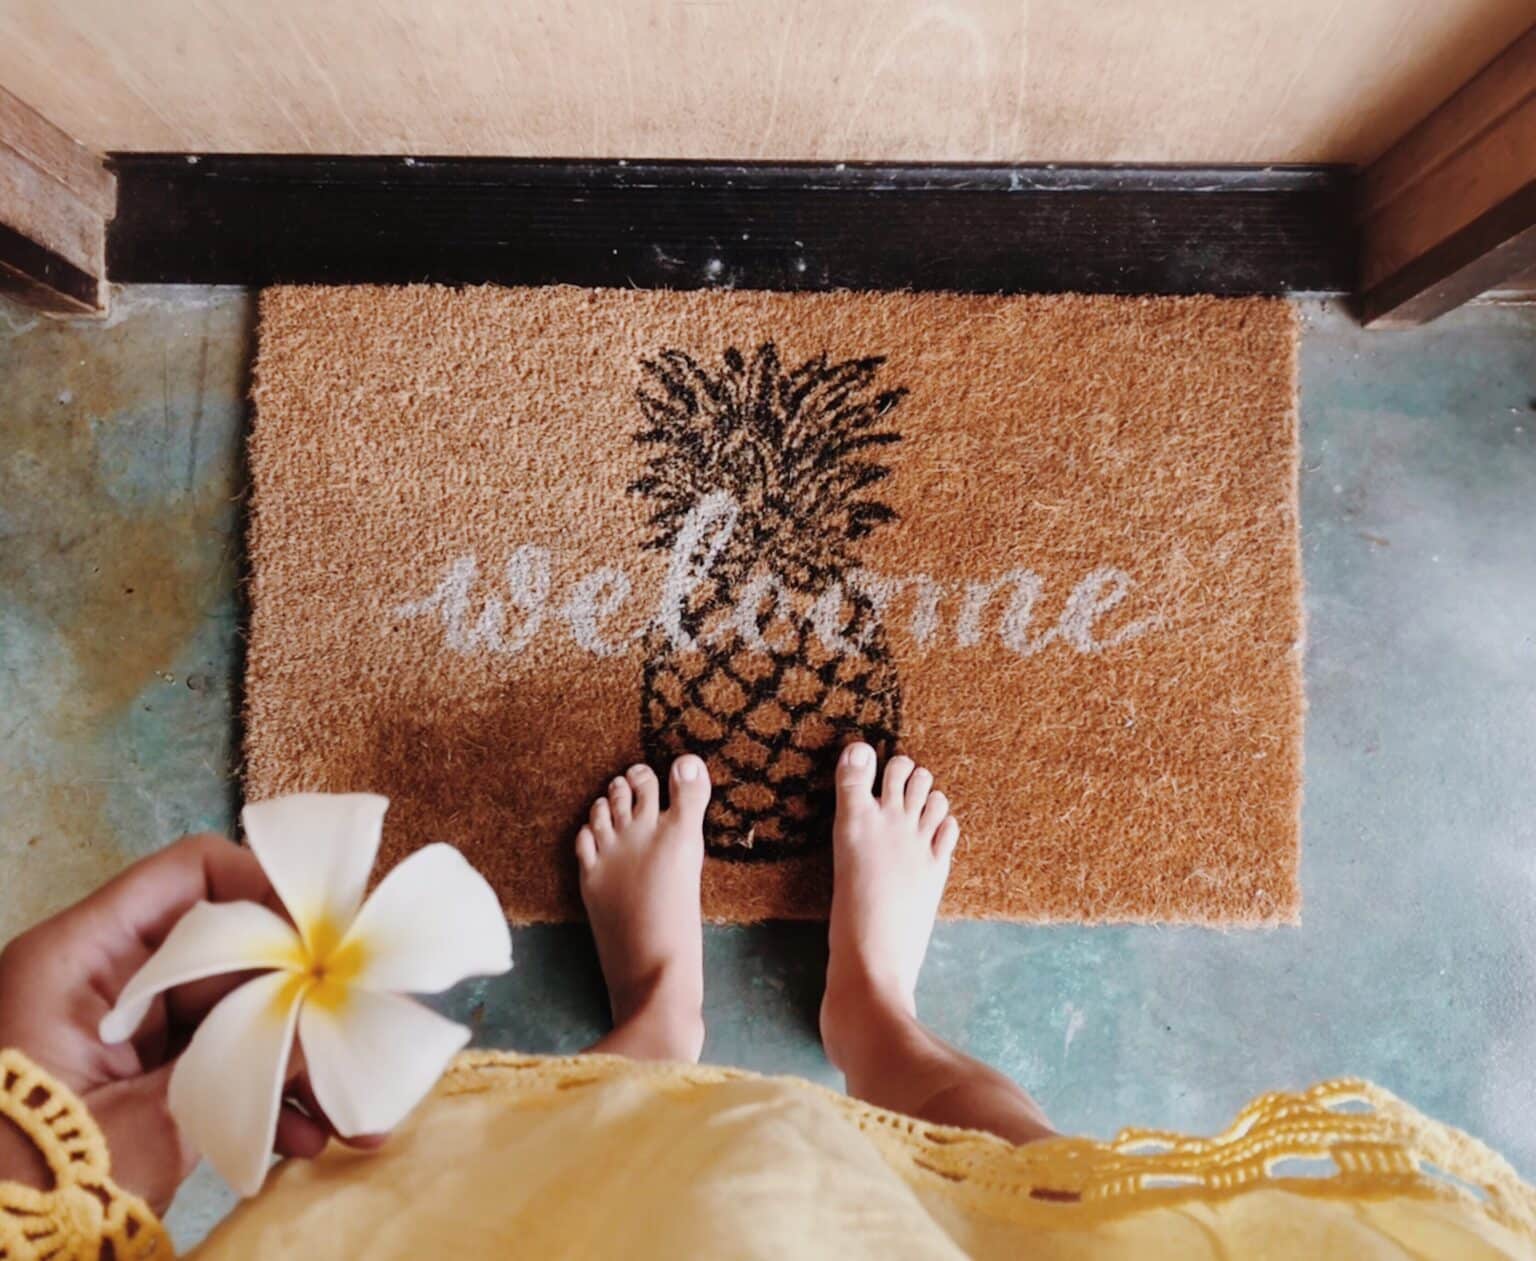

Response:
(0, 289), (1536, 1243)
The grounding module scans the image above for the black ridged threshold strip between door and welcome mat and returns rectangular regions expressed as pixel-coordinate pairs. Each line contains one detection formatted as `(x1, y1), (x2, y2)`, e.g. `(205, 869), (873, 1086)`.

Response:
(108, 154), (1355, 295)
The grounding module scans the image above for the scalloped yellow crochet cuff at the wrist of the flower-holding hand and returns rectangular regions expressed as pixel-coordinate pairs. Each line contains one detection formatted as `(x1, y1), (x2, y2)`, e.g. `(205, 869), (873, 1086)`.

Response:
(0, 1051), (175, 1261)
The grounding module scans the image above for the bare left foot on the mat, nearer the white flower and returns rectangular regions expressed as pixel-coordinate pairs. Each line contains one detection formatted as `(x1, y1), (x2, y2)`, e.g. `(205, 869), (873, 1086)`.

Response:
(576, 754), (710, 1061)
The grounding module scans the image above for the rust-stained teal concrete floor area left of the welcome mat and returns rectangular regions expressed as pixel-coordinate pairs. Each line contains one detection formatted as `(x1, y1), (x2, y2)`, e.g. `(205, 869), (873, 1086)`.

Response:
(0, 290), (250, 940)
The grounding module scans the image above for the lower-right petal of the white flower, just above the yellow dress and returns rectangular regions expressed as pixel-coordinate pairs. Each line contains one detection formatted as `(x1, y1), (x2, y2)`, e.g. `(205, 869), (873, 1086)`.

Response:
(298, 986), (470, 1138)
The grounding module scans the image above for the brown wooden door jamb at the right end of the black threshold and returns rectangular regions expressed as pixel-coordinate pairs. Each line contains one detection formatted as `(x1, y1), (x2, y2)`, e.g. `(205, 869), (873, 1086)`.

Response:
(1356, 26), (1536, 327)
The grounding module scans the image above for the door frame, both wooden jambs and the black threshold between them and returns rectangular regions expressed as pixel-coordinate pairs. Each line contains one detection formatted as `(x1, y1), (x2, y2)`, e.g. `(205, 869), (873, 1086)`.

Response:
(0, 26), (1536, 327)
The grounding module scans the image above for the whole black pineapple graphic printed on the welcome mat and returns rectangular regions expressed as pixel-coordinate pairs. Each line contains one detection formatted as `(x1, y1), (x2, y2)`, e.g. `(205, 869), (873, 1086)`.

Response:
(630, 343), (906, 859)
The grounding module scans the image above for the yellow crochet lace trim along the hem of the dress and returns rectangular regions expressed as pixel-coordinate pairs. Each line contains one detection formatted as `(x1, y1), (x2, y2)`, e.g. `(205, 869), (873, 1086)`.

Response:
(439, 1052), (1536, 1239)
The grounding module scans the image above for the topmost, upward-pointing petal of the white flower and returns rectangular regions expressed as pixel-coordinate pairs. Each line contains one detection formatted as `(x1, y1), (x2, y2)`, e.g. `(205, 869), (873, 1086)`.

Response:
(240, 793), (389, 954)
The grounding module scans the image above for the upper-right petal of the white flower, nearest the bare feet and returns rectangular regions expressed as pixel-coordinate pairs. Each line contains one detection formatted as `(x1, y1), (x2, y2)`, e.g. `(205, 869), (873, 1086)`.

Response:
(344, 845), (511, 994)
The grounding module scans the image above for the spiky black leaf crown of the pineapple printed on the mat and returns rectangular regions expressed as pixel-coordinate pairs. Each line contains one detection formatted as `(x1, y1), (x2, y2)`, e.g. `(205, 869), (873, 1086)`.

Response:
(630, 341), (906, 585)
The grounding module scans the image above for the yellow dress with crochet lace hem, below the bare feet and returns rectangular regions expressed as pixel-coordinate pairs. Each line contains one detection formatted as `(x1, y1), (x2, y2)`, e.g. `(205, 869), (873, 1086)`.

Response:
(0, 1054), (1536, 1261)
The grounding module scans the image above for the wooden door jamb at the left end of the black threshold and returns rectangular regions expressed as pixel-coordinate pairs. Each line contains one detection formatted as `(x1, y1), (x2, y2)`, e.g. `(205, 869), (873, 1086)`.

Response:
(0, 89), (117, 315)
